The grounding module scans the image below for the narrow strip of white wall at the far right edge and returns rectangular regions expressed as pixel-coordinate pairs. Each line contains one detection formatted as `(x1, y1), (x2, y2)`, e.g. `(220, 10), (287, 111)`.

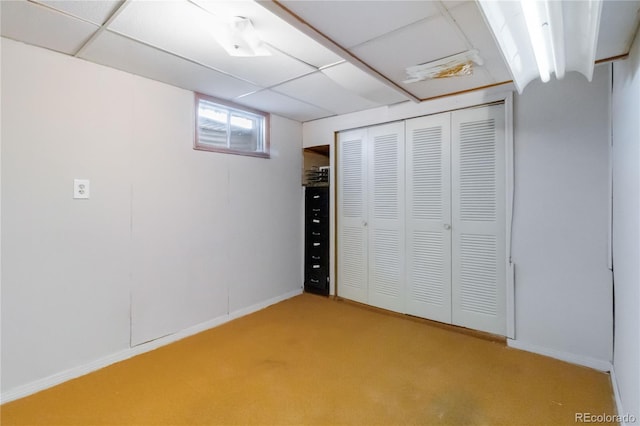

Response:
(613, 31), (640, 419)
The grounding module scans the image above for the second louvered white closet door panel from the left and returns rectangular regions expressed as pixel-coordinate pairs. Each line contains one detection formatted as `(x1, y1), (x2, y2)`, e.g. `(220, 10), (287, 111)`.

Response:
(367, 123), (404, 312)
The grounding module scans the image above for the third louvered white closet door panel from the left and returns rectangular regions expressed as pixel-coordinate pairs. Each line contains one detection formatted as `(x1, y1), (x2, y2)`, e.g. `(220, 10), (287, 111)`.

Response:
(405, 113), (451, 323)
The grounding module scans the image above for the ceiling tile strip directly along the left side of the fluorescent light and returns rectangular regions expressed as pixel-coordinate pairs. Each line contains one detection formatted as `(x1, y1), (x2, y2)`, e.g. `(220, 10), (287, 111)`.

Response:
(449, 2), (511, 83)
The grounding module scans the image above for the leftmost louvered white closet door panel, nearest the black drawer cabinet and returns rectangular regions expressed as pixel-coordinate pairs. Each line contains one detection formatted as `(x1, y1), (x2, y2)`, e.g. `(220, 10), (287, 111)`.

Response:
(337, 129), (368, 303)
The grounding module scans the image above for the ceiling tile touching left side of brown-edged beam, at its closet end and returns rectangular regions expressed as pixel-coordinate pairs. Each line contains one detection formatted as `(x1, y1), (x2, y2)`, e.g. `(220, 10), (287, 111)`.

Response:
(322, 62), (408, 105)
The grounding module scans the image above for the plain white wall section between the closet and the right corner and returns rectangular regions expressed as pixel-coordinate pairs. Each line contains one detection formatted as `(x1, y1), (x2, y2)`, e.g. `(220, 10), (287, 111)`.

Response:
(513, 65), (613, 366)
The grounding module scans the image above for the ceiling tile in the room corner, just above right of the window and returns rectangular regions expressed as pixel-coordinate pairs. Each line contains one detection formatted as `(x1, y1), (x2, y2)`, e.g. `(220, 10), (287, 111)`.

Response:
(233, 90), (335, 122)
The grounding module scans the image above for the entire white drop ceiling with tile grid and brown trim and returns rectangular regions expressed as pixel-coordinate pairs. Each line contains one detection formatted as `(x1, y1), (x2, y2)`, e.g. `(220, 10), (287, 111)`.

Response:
(0, 0), (640, 121)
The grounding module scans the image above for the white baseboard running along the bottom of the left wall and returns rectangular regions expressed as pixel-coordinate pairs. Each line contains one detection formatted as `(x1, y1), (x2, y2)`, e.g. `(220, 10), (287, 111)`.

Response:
(0, 289), (302, 404)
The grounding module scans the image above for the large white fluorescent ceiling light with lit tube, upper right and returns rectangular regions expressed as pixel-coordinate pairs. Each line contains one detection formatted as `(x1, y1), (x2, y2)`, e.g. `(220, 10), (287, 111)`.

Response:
(478, 0), (602, 93)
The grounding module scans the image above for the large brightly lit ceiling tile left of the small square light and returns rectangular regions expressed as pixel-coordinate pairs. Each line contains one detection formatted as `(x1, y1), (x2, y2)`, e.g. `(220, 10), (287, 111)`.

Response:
(109, 1), (315, 87)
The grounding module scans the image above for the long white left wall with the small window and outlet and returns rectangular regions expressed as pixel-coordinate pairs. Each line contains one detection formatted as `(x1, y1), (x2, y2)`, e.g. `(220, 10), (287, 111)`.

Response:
(1, 39), (303, 398)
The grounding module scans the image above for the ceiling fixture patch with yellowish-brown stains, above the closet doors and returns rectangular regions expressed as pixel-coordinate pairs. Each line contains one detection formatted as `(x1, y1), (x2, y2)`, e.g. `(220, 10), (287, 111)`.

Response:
(403, 49), (484, 84)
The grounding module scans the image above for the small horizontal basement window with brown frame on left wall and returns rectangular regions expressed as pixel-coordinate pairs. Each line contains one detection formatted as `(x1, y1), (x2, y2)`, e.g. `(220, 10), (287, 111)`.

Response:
(194, 93), (269, 158)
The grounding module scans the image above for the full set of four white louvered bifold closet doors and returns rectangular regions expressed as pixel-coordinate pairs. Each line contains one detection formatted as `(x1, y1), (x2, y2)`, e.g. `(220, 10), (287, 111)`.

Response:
(337, 105), (506, 335)
